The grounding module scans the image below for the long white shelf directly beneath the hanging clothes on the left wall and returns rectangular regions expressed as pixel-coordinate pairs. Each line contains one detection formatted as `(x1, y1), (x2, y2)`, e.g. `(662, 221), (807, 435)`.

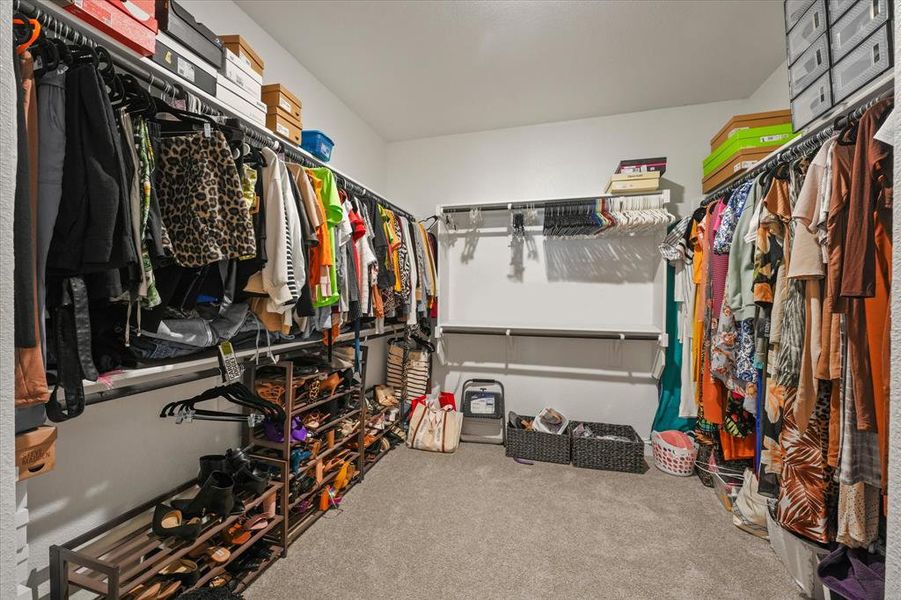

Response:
(84, 325), (404, 404)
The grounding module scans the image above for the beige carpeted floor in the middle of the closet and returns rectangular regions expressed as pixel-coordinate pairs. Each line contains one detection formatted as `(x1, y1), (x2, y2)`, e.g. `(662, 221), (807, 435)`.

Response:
(245, 444), (802, 600)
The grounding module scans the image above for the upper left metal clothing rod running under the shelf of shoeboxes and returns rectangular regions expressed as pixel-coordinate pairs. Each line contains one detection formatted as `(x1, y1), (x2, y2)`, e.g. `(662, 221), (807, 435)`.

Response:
(13, 0), (415, 220)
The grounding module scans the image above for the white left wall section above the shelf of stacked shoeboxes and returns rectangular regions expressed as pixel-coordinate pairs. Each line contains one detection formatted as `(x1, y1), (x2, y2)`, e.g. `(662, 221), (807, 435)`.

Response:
(179, 0), (385, 193)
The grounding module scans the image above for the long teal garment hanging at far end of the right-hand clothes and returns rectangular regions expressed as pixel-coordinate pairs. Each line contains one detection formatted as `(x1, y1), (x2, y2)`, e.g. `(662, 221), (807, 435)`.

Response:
(651, 265), (696, 432)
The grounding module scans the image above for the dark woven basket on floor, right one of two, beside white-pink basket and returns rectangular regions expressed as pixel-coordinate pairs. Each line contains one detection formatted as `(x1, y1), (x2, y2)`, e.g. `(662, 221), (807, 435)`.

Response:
(570, 421), (648, 473)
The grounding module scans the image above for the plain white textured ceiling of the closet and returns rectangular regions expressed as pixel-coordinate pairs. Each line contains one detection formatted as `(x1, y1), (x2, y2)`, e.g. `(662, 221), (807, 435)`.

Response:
(238, 0), (785, 141)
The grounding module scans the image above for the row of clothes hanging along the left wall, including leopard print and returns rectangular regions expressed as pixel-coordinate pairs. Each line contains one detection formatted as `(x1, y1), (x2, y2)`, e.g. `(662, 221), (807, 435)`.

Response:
(6, 15), (428, 421)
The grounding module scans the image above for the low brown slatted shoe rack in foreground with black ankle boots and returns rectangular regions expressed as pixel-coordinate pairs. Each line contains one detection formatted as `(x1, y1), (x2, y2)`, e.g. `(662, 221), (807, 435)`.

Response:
(50, 474), (287, 600)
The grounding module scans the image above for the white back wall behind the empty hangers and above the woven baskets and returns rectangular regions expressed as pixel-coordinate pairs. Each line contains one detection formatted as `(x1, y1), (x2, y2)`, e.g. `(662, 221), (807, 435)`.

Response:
(387, 65), (788, 437)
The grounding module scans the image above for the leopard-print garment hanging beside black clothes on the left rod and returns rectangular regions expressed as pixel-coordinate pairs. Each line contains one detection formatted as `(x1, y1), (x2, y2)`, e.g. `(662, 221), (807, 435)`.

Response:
(157, 131), (256, 267)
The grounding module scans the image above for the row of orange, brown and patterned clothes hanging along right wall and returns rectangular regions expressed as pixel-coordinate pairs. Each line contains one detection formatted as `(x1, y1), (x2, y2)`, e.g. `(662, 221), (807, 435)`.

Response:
(661, 98), (893, 548)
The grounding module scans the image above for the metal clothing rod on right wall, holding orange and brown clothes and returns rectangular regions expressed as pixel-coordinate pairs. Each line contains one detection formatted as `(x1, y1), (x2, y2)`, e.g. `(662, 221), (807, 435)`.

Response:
(701, 79), (894, 200)
